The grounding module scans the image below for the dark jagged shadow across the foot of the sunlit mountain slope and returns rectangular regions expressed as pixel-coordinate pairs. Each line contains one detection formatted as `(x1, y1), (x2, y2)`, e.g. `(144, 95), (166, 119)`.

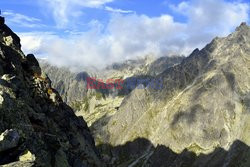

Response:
(97, 138), (250, 167)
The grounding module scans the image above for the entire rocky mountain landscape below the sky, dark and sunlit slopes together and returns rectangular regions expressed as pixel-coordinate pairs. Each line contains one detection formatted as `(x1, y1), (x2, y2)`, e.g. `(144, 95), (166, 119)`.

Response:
(0, 17), (250, 167)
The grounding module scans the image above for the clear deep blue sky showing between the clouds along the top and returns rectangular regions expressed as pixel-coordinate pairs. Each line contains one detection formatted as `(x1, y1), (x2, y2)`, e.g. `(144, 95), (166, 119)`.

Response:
(0, 0), (189, 33)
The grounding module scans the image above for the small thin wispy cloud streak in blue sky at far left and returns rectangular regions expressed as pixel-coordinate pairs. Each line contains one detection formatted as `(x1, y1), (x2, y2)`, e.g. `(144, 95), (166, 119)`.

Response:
(2, 10), (45, 28)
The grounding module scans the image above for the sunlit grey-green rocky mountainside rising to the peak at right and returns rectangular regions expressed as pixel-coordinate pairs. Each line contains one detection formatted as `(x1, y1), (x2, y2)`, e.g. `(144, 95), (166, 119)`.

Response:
(98, 23), (250, 166)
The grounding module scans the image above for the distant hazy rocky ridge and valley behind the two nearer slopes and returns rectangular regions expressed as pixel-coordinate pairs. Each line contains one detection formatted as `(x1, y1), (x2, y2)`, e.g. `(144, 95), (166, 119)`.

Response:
(39, 53), (184, 137)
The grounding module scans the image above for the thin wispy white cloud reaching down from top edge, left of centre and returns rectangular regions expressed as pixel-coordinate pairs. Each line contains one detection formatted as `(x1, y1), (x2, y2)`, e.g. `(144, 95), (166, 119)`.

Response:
(40, 0), (114, 28)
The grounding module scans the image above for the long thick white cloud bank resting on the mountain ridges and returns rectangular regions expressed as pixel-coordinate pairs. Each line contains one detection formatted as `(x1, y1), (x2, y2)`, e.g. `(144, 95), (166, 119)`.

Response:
(21, 0), (249, 70)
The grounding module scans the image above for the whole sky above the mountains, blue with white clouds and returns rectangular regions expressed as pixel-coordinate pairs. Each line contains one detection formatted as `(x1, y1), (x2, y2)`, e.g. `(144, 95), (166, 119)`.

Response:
(0, 0), (250, 67)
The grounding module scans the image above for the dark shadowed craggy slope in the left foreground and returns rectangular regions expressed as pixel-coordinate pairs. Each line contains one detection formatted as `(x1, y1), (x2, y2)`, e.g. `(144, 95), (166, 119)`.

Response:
(0, 18), (103, 167)
